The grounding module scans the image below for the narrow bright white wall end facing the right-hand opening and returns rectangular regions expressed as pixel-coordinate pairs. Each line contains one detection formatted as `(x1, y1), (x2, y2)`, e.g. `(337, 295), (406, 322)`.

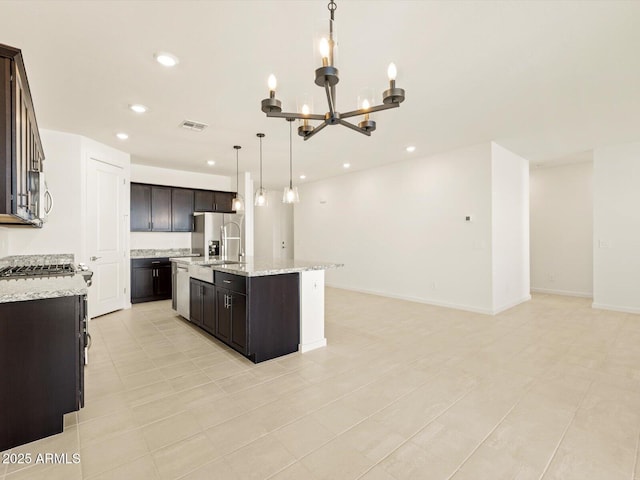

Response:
(491, 143), (531, 313)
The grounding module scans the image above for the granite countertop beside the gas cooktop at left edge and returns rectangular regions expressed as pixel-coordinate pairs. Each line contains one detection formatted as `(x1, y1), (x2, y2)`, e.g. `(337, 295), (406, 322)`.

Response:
(0, 274), (87, 303)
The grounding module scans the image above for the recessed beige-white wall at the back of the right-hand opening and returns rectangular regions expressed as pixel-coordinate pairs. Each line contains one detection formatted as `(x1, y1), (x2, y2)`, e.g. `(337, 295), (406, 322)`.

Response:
(530, 162), (593, 297)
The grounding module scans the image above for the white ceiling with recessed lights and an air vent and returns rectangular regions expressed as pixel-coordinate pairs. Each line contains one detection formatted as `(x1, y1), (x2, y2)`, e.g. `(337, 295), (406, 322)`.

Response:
(0, 0), (640, 187)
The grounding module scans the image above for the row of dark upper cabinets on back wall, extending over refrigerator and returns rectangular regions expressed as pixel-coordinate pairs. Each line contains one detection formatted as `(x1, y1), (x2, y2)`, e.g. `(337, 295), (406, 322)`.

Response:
(131, 183), (235, 232)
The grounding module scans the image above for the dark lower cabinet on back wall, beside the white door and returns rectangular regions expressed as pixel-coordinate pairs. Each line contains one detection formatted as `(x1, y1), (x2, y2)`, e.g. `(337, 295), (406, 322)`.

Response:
(131, 258), (172, 303)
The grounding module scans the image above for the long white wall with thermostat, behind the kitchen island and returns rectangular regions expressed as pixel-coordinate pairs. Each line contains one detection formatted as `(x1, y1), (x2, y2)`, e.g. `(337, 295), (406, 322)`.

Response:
(294, 143), (493, 313)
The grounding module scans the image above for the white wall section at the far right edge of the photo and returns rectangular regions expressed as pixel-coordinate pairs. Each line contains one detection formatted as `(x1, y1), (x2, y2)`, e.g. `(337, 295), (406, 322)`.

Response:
(593, 143), (640, 313)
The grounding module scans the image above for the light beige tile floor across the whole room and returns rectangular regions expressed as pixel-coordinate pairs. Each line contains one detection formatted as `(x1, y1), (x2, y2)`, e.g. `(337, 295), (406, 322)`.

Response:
(0, 288), (640, 480)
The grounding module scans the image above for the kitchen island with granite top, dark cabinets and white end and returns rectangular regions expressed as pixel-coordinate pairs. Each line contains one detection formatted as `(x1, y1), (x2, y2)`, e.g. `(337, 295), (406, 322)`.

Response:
(171, 257), (342, 363)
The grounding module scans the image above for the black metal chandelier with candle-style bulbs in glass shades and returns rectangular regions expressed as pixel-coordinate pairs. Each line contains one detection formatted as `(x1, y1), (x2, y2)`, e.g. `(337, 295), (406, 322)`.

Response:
(262, 0), (404, 140)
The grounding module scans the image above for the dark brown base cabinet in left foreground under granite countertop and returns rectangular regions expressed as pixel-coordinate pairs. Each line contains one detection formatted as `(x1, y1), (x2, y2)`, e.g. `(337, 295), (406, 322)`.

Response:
(0, 296), (86, 451)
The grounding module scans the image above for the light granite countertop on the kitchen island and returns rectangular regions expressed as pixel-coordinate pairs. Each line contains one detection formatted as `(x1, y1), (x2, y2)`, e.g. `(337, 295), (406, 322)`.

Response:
(171, 257), (344, 277)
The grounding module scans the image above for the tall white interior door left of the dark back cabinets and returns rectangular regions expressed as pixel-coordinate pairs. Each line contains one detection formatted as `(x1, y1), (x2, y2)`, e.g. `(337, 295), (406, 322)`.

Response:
(86, 158), (127, 318)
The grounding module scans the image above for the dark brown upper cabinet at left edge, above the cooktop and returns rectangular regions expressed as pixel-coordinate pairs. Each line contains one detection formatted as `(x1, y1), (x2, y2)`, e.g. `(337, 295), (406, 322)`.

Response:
(0, 44), (44, 227)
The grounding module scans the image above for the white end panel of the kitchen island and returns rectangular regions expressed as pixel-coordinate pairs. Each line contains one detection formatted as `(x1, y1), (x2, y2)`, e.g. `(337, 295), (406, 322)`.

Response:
(300, 270), (327, 353)
